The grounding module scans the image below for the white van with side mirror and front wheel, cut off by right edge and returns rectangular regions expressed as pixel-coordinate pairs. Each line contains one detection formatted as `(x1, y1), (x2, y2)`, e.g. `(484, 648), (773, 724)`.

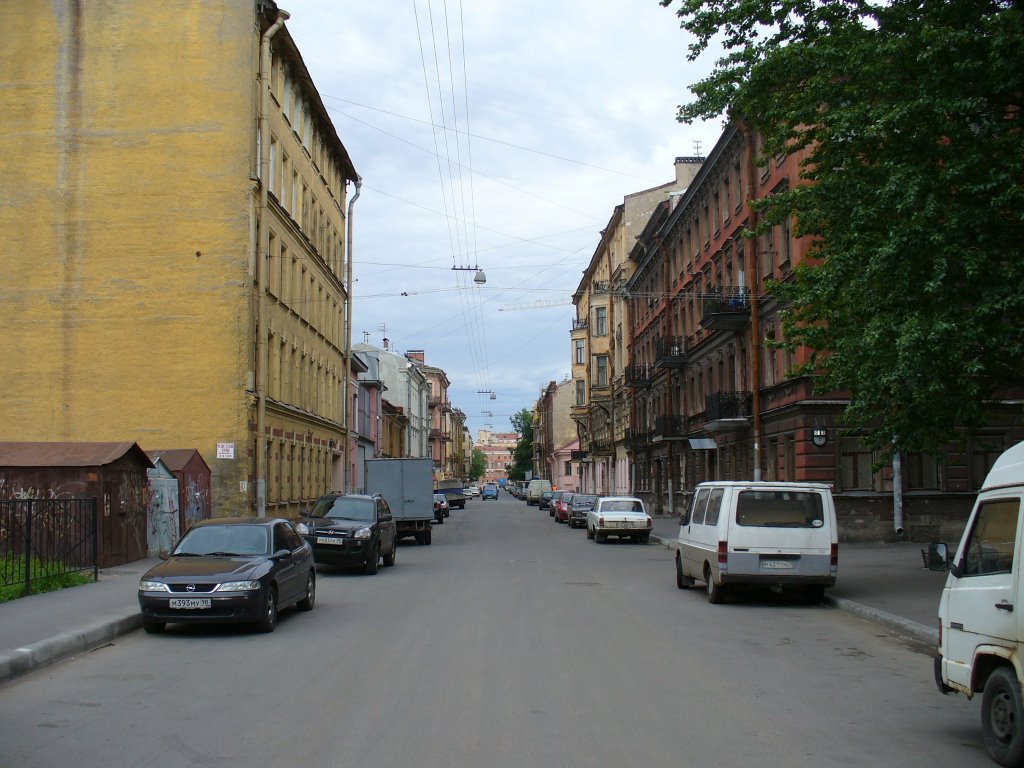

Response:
(929, 442), (1024, 766)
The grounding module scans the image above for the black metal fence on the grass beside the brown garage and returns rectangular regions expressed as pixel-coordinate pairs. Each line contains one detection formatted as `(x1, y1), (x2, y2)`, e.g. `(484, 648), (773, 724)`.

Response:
(0, 499), (99, 594)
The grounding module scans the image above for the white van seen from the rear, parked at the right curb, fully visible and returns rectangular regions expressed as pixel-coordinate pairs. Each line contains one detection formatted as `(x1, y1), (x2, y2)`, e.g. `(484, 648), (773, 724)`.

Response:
(676, 481), (839, 603)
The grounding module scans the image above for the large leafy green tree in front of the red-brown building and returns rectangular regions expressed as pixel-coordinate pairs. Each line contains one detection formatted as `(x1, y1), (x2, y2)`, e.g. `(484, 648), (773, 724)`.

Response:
(662, 0), (1024, 454)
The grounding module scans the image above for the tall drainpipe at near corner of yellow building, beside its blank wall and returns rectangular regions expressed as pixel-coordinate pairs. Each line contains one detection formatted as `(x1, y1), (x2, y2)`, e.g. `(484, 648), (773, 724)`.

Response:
(255, 9), (291, 517)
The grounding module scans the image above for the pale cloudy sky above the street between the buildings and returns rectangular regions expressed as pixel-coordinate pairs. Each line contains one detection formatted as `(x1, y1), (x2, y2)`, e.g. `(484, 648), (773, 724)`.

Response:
(279, 0), (722, 440)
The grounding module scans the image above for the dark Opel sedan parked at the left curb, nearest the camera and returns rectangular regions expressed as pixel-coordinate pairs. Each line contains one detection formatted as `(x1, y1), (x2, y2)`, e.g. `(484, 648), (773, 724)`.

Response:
(138, 517), (316, 634)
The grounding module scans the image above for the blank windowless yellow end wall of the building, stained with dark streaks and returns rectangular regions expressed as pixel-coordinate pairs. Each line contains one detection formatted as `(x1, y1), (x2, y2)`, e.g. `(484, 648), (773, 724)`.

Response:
(0, 0), (258, 514)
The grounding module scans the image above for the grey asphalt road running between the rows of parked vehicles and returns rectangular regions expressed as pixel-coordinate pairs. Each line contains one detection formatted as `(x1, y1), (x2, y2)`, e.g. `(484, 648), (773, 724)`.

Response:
(0, 494), (992, 768)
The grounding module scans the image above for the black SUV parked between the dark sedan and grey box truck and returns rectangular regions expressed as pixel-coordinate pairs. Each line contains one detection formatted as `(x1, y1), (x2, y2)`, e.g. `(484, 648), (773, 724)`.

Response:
(295, 494), (398, 574)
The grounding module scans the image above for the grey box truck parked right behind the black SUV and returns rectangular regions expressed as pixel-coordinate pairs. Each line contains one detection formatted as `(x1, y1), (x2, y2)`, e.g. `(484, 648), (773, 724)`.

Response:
(366, 459), (434, 544)
